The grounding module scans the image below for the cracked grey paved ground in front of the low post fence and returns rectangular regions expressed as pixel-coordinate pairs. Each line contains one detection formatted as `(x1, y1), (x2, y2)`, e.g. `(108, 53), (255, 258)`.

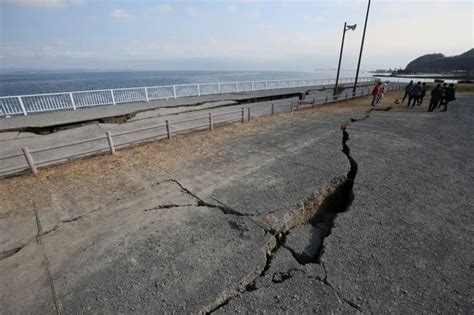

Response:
(0, 92), (474, 314)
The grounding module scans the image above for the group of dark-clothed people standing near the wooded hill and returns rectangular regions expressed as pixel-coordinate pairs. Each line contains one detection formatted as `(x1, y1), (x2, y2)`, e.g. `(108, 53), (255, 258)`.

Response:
(402, 81), (456, 112)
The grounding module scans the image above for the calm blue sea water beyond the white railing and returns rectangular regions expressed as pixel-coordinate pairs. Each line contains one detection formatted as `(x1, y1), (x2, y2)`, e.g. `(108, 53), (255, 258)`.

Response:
(0, 70), (367, 96)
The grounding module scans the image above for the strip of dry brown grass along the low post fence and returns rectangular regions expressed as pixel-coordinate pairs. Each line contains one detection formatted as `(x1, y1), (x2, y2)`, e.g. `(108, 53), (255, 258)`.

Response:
(0, 92), (400, 218)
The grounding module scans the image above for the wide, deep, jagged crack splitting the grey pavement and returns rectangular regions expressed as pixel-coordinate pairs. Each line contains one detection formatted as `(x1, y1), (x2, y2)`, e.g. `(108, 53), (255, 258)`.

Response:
(200, 118), (362, 314)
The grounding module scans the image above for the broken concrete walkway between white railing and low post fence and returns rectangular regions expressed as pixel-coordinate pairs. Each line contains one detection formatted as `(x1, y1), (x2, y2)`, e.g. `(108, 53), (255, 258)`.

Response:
(0, 81), (378, 175)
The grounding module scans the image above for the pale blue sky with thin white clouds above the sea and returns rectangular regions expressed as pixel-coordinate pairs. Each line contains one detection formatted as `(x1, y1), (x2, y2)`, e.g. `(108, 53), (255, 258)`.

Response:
(0, 0), (474, 71)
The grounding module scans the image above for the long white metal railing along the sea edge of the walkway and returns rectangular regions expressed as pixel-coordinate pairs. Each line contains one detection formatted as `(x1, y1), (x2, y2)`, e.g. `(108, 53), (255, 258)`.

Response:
(0, 77), (374, 117)
